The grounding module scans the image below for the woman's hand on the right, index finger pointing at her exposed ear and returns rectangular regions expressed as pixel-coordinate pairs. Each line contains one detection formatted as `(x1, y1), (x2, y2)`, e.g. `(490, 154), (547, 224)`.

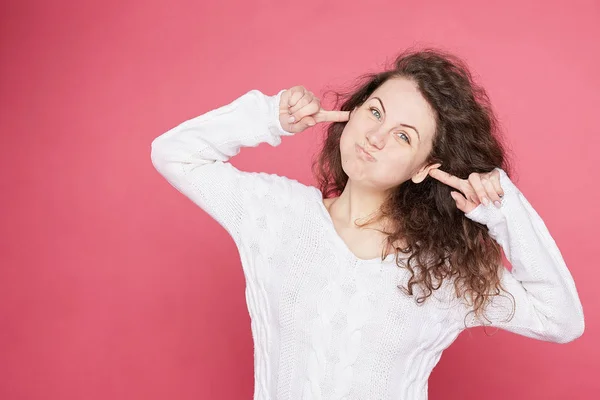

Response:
(429, 168), (504, 214)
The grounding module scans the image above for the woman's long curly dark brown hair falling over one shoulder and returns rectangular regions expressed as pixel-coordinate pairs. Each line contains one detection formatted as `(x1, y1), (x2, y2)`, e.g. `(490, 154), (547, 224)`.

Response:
(313, 48), (510, 326)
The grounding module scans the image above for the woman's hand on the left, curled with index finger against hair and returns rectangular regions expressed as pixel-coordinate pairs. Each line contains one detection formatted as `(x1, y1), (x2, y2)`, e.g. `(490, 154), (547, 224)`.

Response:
(279, 86), (350, 133)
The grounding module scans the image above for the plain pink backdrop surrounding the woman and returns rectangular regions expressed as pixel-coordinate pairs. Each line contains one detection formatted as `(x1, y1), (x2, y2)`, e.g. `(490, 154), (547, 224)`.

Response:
(0, 0), (600, 400)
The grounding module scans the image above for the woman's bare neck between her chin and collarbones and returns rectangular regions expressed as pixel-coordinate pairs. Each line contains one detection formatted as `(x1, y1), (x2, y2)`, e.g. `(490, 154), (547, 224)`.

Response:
(329, 180), (387, 229)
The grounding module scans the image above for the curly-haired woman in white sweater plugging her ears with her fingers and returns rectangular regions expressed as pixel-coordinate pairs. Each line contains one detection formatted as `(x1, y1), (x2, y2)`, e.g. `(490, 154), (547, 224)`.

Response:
(151, 49), (584, 400)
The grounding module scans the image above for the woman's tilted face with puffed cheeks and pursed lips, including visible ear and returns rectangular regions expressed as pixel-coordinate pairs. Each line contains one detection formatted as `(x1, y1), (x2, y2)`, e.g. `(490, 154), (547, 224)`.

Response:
(340, 78), (439, 191)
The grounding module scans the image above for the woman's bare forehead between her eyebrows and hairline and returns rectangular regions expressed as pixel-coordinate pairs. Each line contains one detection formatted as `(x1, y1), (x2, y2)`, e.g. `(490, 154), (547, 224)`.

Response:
(368, 78), (435, 135)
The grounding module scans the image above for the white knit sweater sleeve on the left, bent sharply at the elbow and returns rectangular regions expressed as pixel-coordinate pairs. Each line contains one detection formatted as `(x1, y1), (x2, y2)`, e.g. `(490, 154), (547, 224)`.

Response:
(151, 89), (293, 243)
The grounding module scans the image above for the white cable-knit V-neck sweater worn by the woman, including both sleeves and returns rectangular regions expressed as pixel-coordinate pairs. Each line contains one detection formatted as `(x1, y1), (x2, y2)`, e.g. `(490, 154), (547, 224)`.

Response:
(151, 90), (584, 400)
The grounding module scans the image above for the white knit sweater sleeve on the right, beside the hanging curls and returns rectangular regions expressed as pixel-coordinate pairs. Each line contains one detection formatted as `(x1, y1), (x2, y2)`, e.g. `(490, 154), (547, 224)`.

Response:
(461, 168), (585, 343)
